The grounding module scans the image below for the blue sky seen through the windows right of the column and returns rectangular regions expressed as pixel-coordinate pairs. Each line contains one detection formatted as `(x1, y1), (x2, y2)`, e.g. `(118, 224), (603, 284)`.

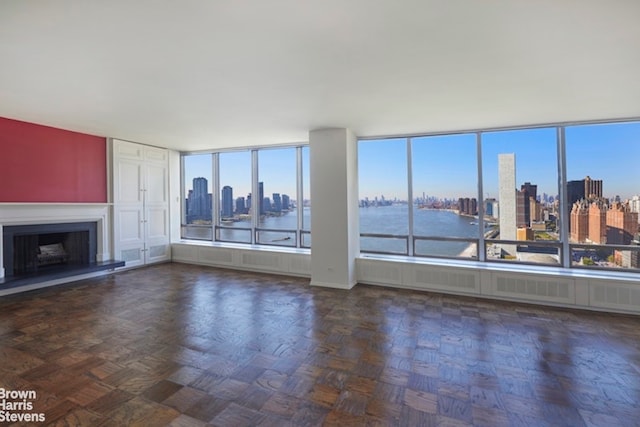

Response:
(358, 122), (640, 200)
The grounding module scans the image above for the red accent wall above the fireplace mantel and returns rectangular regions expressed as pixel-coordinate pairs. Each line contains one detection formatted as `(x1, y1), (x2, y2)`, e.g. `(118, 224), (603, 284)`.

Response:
(0, 117), (107, 203)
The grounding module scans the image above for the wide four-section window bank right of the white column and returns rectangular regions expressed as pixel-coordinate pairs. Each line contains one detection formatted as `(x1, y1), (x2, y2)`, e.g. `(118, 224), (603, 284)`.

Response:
(358, 118), (640, 270)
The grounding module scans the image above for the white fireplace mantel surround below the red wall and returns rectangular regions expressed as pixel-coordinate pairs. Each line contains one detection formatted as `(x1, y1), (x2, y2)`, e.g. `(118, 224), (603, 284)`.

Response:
(0, 203), (113, 278)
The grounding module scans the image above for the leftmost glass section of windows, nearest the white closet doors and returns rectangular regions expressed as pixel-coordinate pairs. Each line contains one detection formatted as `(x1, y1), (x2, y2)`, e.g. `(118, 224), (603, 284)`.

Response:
(182, 154), (213, 239)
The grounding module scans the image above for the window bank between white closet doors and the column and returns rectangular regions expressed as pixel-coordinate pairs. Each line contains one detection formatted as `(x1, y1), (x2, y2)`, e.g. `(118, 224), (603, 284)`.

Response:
(182, 146), (311, 247)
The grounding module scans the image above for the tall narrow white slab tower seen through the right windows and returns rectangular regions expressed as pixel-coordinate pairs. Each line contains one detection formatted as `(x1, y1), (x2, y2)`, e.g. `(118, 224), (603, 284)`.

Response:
(498, 153), (517, 254)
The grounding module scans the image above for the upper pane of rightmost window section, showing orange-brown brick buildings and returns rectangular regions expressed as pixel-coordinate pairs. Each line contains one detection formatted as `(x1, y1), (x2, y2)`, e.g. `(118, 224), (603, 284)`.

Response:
(565, 122), (640, 258)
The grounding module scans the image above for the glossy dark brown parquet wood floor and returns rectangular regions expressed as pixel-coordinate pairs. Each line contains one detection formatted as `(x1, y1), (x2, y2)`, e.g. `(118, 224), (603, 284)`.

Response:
(0, 264), (640, 427)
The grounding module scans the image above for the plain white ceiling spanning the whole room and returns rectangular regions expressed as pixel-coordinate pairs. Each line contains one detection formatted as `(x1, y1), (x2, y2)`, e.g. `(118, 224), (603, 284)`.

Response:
(0, 0), (640, 150)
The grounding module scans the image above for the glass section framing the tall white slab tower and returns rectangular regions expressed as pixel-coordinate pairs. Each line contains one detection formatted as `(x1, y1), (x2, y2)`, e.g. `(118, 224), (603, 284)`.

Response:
(482, 128), (560, 264)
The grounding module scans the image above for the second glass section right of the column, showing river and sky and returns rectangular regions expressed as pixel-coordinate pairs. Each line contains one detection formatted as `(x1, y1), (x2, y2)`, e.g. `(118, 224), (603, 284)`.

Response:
(411, 134), (480, 256)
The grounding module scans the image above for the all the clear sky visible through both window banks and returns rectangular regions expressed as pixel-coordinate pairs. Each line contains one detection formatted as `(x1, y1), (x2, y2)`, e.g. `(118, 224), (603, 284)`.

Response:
(185, 118), (640, 200)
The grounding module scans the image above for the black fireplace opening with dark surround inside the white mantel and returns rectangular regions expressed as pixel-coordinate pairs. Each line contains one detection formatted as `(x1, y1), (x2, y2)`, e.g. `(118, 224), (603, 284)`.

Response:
(2, 222), (97, 277)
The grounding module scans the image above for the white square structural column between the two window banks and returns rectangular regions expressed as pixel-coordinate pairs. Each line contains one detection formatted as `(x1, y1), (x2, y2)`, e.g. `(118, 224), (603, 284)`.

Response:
(309, 128), (360, 289)
